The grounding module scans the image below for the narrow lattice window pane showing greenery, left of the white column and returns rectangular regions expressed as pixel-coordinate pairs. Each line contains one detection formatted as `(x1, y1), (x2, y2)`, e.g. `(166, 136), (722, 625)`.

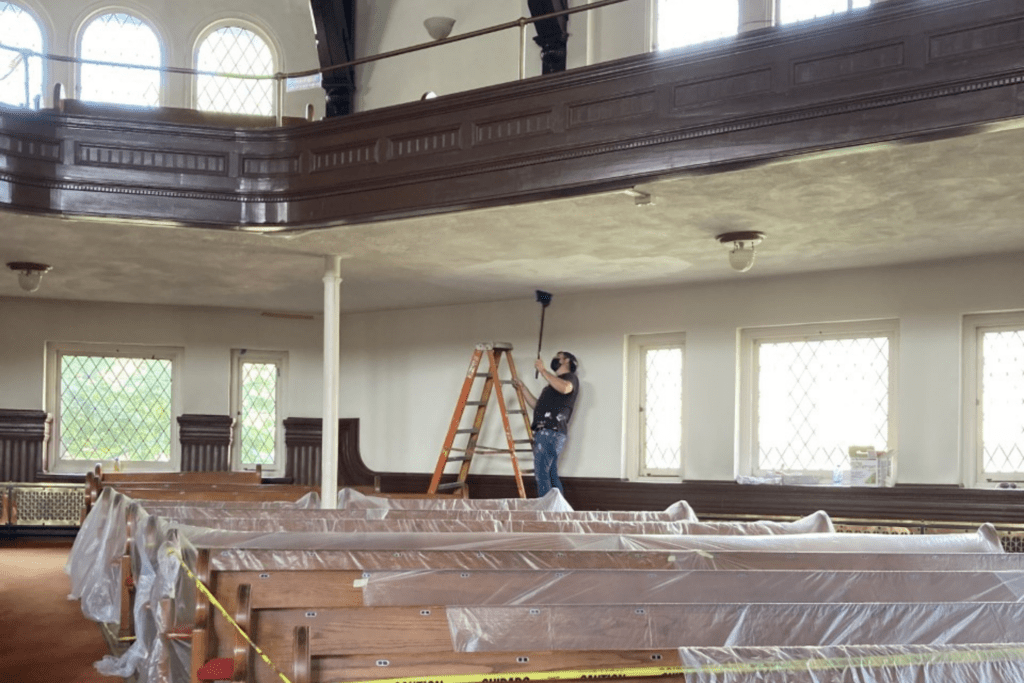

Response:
(239, 362), (278, 465)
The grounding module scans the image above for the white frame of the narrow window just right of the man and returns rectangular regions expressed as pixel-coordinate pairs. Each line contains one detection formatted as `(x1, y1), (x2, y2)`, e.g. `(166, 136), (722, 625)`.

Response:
(623, 332), (689, 483)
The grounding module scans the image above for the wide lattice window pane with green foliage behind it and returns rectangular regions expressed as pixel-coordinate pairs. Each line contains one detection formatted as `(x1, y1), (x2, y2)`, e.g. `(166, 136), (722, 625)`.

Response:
(58, 355), (172, 463)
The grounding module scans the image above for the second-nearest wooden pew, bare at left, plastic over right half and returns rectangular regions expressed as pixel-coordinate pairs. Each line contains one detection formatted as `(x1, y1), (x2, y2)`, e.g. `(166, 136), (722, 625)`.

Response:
(258, 590), (1024, 683)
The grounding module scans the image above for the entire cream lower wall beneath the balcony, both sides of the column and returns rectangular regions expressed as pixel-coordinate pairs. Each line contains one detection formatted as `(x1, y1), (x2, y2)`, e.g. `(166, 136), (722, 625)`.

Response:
(0, 254), (1024, 484)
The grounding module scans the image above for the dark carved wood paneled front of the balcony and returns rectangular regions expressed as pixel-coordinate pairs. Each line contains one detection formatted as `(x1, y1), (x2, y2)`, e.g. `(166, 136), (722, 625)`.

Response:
(0, 0), (1024, 229)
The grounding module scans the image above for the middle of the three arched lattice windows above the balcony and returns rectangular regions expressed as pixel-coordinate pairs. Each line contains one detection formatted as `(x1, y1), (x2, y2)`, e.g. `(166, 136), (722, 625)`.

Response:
(78, 12), (163, 106)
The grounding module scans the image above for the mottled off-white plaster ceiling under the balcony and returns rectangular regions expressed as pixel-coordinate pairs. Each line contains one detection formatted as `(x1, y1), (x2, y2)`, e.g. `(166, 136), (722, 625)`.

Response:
(0, 122), (1024, 312)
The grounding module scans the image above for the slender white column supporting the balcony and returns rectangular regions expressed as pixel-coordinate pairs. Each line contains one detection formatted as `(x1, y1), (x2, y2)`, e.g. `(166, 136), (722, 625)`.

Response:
(321, 256), (341, 510)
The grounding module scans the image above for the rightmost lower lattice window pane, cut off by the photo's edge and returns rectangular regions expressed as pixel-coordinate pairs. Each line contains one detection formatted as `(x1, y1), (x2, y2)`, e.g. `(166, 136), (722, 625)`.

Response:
(980, 330), (1024, 474)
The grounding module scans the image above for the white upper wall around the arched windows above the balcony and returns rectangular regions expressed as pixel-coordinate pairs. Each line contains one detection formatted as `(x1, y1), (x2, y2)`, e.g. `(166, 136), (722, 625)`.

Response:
(17, 0), (768, 119)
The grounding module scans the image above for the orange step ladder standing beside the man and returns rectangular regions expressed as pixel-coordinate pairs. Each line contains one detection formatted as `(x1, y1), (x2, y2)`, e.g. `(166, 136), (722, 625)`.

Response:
(427, 342), (534, 498)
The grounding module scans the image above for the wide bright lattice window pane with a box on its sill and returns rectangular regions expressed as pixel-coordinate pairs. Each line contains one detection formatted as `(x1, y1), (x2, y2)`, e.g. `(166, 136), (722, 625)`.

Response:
(755, 337), (890, 471)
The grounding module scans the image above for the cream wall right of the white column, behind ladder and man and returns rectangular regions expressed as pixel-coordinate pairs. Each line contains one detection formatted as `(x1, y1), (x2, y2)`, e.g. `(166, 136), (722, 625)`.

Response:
(341, 254), (1024, 484)
